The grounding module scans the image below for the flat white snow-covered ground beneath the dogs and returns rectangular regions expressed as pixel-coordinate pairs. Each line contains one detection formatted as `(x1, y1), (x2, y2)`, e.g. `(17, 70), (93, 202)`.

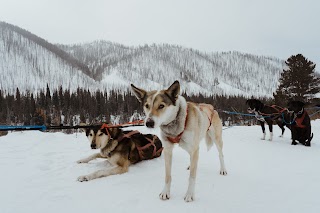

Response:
(0, 120), (320, 213)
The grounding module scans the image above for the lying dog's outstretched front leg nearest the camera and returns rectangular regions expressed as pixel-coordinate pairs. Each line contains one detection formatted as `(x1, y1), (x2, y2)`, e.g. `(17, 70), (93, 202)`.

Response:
(78, 166), (129, 182)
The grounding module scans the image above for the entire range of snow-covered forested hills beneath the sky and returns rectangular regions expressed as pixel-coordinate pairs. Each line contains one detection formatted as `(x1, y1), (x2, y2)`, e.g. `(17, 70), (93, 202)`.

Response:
(0, 22), (284, 97)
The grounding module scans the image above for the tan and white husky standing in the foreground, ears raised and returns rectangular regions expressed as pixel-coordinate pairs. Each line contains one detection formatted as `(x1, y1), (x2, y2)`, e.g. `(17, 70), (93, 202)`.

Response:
(131, 81), (227, 202)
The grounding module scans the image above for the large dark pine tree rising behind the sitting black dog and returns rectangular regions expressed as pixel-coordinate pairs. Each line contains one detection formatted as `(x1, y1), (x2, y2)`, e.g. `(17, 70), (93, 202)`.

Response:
(273, 54), (320, 105)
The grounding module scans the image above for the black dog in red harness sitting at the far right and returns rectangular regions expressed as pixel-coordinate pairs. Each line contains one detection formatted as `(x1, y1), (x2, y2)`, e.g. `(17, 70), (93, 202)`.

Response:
(287, 101), (313, 146)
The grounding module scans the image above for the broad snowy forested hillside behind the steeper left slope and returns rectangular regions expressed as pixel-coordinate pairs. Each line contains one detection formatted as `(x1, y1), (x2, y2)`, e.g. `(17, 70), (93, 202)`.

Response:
(61, 41), (284, 97)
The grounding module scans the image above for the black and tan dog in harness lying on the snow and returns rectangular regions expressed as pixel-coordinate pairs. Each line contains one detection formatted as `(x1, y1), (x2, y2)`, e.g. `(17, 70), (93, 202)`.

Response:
(77, 125), (163, 182)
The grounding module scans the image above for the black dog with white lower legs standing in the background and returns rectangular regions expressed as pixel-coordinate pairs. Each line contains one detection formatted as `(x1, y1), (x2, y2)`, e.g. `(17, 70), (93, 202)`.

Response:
(246, 99), (290, 141)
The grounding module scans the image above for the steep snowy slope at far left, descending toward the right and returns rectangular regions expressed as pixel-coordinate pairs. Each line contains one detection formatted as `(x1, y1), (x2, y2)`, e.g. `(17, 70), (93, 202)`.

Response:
(0, 22), (98, 93)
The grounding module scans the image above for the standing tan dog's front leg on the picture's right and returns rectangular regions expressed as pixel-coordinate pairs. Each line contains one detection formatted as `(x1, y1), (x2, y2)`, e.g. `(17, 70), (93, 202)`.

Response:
(184, 147), (199, 202)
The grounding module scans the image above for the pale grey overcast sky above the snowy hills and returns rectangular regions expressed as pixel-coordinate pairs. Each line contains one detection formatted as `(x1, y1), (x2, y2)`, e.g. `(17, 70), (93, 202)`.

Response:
(0, 0), (320, 65)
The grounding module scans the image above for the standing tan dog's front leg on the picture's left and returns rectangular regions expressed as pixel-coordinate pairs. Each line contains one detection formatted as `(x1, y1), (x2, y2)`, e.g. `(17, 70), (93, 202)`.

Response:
(159, 142), (173, 200)
